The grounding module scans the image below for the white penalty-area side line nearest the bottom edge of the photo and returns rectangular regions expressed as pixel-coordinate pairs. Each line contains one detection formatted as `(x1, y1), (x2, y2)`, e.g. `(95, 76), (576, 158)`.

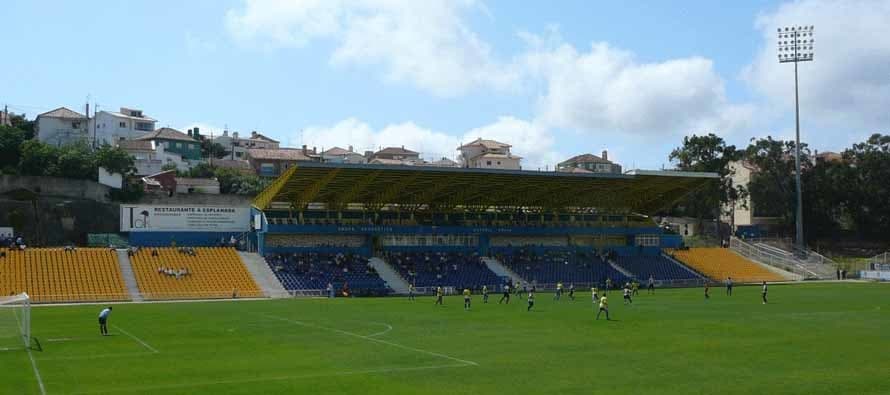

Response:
(71, 363), (469, 395)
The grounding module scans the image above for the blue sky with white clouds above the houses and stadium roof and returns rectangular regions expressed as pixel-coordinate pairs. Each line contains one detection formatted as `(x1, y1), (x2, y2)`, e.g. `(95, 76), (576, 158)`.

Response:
(0, 0), (890, 170)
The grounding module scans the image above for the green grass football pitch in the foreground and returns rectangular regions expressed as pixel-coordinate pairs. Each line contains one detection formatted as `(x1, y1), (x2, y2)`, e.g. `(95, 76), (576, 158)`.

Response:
(0, 284), (890, 395)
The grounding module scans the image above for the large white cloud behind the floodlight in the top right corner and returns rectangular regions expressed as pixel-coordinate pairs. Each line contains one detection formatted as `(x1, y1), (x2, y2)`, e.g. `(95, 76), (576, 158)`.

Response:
(743, 0), (890, 131)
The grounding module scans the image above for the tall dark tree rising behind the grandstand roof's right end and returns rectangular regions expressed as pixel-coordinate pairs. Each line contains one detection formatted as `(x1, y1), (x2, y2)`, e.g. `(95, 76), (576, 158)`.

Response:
(669, 133), (746, 235)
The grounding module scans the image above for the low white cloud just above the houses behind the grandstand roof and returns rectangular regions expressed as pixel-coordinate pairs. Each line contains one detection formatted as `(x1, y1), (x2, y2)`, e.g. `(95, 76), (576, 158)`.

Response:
(303, 117), (560, 169)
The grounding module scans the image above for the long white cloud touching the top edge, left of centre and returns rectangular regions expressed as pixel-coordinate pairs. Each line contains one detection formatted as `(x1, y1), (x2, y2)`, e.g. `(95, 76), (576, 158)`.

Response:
(227, 0), (518, 96)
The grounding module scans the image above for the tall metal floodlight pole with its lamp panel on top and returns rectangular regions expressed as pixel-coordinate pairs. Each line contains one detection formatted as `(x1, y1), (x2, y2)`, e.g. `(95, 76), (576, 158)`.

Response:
(777, 25), (814, 253)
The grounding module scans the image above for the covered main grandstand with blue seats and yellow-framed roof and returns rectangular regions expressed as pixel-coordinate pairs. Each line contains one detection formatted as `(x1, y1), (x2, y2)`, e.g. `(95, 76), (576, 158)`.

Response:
(251, 163), (715, 291)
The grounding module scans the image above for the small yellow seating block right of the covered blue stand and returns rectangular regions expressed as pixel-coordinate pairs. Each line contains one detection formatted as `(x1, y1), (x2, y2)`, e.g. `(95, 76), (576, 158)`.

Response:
(667, 247), (786, 283)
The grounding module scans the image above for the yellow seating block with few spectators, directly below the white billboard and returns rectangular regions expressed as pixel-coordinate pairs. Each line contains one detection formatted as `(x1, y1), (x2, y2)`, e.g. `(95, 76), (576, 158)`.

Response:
(130, 247), (263, 300)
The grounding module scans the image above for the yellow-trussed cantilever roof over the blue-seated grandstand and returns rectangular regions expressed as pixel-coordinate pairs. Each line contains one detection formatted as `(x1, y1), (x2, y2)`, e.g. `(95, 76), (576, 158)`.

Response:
(253, 162), (718, 214)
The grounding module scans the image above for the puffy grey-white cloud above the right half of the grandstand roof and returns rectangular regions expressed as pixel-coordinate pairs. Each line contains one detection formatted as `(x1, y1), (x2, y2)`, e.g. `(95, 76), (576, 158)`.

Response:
(525, 38), (753, 135)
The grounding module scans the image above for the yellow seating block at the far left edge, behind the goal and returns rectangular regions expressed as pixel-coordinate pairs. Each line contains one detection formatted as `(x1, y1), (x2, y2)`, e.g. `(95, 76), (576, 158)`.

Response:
(0, 248), (129, 303)
